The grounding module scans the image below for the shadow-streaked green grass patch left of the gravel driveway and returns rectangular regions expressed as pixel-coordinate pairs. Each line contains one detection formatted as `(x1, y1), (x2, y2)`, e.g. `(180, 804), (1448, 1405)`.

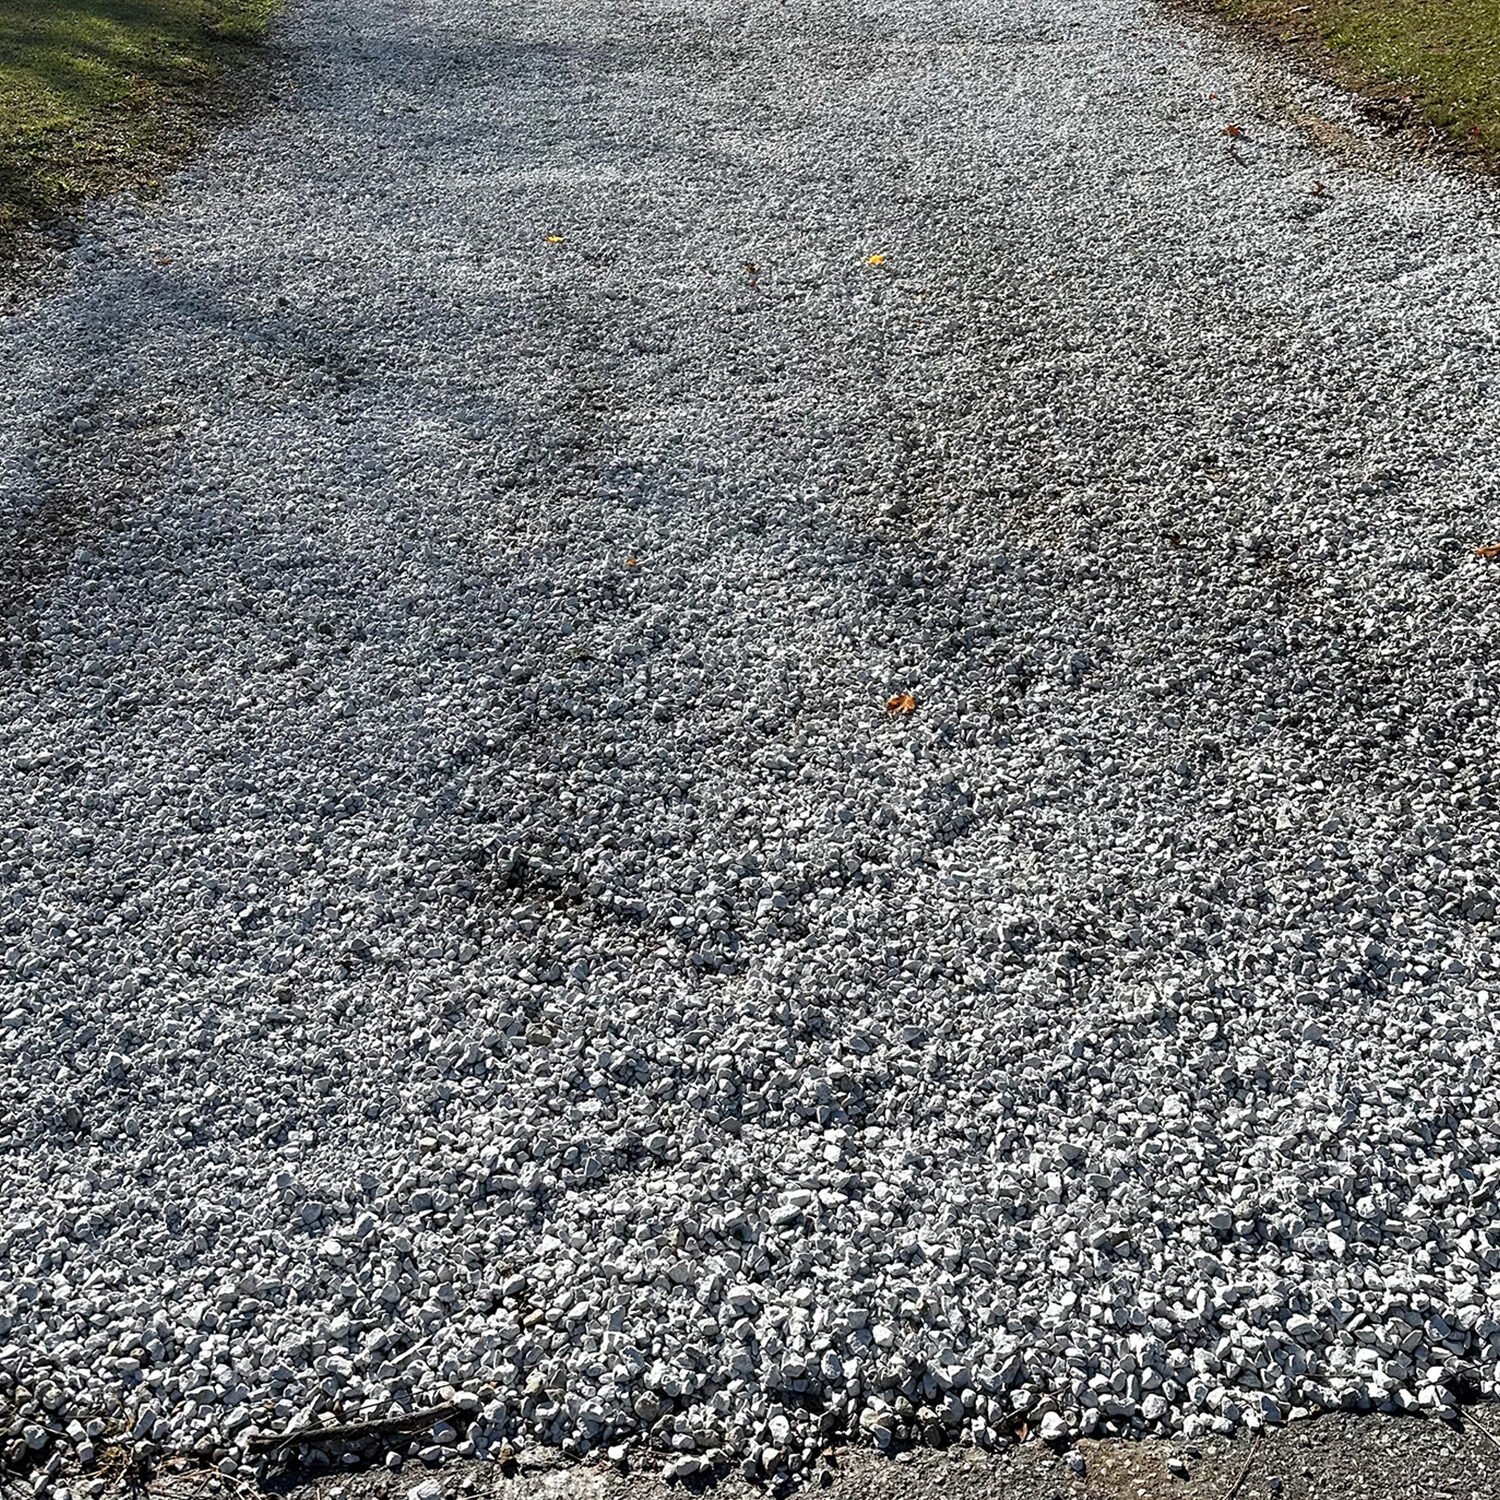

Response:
(0, 0), (278, 251)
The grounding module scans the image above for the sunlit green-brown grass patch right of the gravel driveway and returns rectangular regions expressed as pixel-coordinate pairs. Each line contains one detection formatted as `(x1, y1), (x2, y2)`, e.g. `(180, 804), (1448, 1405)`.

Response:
(1194, 0), (1500, 165)
